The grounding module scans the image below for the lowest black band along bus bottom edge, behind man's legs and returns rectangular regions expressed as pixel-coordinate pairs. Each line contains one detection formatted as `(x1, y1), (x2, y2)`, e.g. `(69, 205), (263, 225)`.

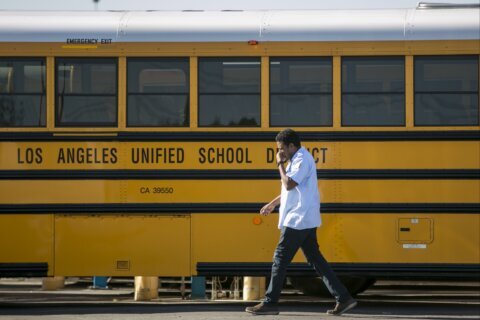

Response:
(197, 262), (480, 280)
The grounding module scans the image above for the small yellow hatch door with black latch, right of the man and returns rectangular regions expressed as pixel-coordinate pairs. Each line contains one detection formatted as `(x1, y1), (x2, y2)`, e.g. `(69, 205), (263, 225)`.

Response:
(397, 218), (433, 244)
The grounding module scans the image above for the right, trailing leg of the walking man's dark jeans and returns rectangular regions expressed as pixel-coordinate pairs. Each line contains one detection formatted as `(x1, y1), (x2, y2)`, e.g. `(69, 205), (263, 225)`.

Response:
(301, 228), (351, 302)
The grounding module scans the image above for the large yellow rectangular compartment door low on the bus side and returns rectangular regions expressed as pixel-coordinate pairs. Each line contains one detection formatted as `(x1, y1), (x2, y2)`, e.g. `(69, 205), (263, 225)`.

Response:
(55, 214), (190, 276)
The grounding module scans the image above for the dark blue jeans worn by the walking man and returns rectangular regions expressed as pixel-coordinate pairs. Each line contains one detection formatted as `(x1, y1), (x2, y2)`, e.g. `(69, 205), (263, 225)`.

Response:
(264, 227), (351, 303)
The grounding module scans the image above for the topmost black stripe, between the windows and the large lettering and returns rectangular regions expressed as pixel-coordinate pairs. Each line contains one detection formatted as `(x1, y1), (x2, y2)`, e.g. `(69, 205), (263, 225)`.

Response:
(0, 130), (480, 143)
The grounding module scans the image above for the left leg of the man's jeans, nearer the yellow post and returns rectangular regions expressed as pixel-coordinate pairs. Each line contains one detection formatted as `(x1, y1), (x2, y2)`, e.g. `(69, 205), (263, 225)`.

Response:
(264, 227), (305, 303)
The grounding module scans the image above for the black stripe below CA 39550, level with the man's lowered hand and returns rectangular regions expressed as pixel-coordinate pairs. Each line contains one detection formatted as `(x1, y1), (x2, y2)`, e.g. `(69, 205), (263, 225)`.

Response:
(0, 203), (480, 215)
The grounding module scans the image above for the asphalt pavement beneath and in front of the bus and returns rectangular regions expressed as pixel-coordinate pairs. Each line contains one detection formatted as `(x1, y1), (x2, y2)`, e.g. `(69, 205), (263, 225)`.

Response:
(0, 279), (480, 320)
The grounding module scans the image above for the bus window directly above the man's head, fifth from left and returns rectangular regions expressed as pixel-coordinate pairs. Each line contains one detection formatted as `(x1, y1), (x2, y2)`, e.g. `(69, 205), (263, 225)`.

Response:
(270, 57), (333, 127)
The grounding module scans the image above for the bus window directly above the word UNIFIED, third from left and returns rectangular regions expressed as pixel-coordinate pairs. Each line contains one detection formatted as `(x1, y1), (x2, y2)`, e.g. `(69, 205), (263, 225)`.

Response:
(127, 58), (190, 127)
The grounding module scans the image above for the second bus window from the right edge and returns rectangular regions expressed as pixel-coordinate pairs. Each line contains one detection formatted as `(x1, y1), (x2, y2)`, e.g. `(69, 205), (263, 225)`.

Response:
(342, 57), (405, 126)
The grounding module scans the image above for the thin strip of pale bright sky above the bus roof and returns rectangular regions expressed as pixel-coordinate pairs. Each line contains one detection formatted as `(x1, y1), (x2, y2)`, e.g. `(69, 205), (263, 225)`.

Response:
(0, 0), (480, 10)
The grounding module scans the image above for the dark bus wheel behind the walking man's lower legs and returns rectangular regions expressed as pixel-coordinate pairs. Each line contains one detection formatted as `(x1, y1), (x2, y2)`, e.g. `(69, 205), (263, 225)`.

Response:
(290, 276), (375, 297)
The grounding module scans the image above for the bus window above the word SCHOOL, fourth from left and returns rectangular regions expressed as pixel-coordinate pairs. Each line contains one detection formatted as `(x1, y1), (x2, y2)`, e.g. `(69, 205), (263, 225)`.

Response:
(198, 58), (260, 127)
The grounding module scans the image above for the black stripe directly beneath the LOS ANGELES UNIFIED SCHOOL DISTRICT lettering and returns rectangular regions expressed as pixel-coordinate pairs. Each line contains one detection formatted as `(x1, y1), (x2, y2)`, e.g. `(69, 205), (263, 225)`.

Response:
(0, 169), (480, 180)
